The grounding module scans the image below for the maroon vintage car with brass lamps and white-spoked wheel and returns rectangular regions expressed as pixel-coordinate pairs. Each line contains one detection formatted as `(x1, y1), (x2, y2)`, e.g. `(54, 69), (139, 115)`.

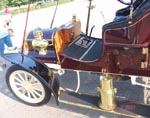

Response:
(5, 0), (150, 117)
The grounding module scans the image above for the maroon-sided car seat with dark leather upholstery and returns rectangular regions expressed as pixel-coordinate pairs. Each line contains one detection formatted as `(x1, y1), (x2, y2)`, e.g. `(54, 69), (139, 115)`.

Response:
(102, 0), (150, 46)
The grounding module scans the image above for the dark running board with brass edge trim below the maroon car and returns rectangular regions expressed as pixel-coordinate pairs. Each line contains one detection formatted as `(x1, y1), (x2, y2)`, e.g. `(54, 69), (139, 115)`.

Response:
(58, 91), (150, 118)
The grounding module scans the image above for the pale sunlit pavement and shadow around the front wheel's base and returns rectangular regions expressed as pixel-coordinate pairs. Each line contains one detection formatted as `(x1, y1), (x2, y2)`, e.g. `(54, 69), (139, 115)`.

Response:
(0, 63), (87, 118)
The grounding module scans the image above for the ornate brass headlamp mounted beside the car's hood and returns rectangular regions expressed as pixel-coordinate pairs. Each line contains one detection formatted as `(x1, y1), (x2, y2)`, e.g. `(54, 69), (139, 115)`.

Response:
(32, 27), (48, 55)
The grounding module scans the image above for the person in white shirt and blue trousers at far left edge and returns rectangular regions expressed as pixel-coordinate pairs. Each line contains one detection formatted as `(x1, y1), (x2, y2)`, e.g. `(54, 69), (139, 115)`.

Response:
(0, 14), (13, 70)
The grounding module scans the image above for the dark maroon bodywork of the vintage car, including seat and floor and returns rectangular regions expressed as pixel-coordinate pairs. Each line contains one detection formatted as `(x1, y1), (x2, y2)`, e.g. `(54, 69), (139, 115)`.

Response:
(27, 0), (150, 76)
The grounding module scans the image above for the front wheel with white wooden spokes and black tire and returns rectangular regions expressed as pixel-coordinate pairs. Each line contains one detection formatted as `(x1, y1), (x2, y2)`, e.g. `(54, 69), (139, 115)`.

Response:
(6, 65), (51, 106)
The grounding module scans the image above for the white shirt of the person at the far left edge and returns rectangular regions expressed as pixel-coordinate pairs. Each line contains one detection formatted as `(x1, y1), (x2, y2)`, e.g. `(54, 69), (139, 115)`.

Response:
(0, 14), (9, 39)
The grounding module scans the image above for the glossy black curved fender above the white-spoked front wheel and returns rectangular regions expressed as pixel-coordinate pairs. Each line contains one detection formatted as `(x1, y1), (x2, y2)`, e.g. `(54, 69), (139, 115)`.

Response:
(4, 53), (59, 104)
